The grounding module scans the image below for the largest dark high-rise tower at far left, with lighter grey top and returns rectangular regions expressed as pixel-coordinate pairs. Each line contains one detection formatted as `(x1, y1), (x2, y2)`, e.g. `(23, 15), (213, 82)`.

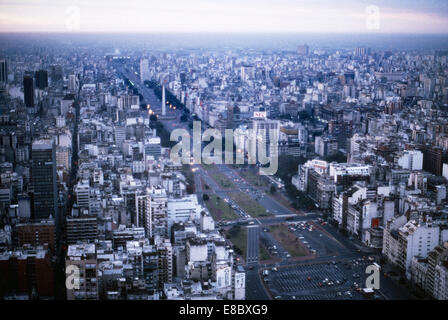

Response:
(31, 139), (59, 221)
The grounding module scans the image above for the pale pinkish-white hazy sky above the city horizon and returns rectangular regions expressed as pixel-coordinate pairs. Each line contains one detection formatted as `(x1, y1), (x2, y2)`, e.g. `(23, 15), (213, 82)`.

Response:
(0, 0), (448, 33)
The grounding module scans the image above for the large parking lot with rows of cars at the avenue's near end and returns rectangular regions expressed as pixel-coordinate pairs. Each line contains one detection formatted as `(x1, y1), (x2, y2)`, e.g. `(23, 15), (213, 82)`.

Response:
(263, 258), (382, 300)
